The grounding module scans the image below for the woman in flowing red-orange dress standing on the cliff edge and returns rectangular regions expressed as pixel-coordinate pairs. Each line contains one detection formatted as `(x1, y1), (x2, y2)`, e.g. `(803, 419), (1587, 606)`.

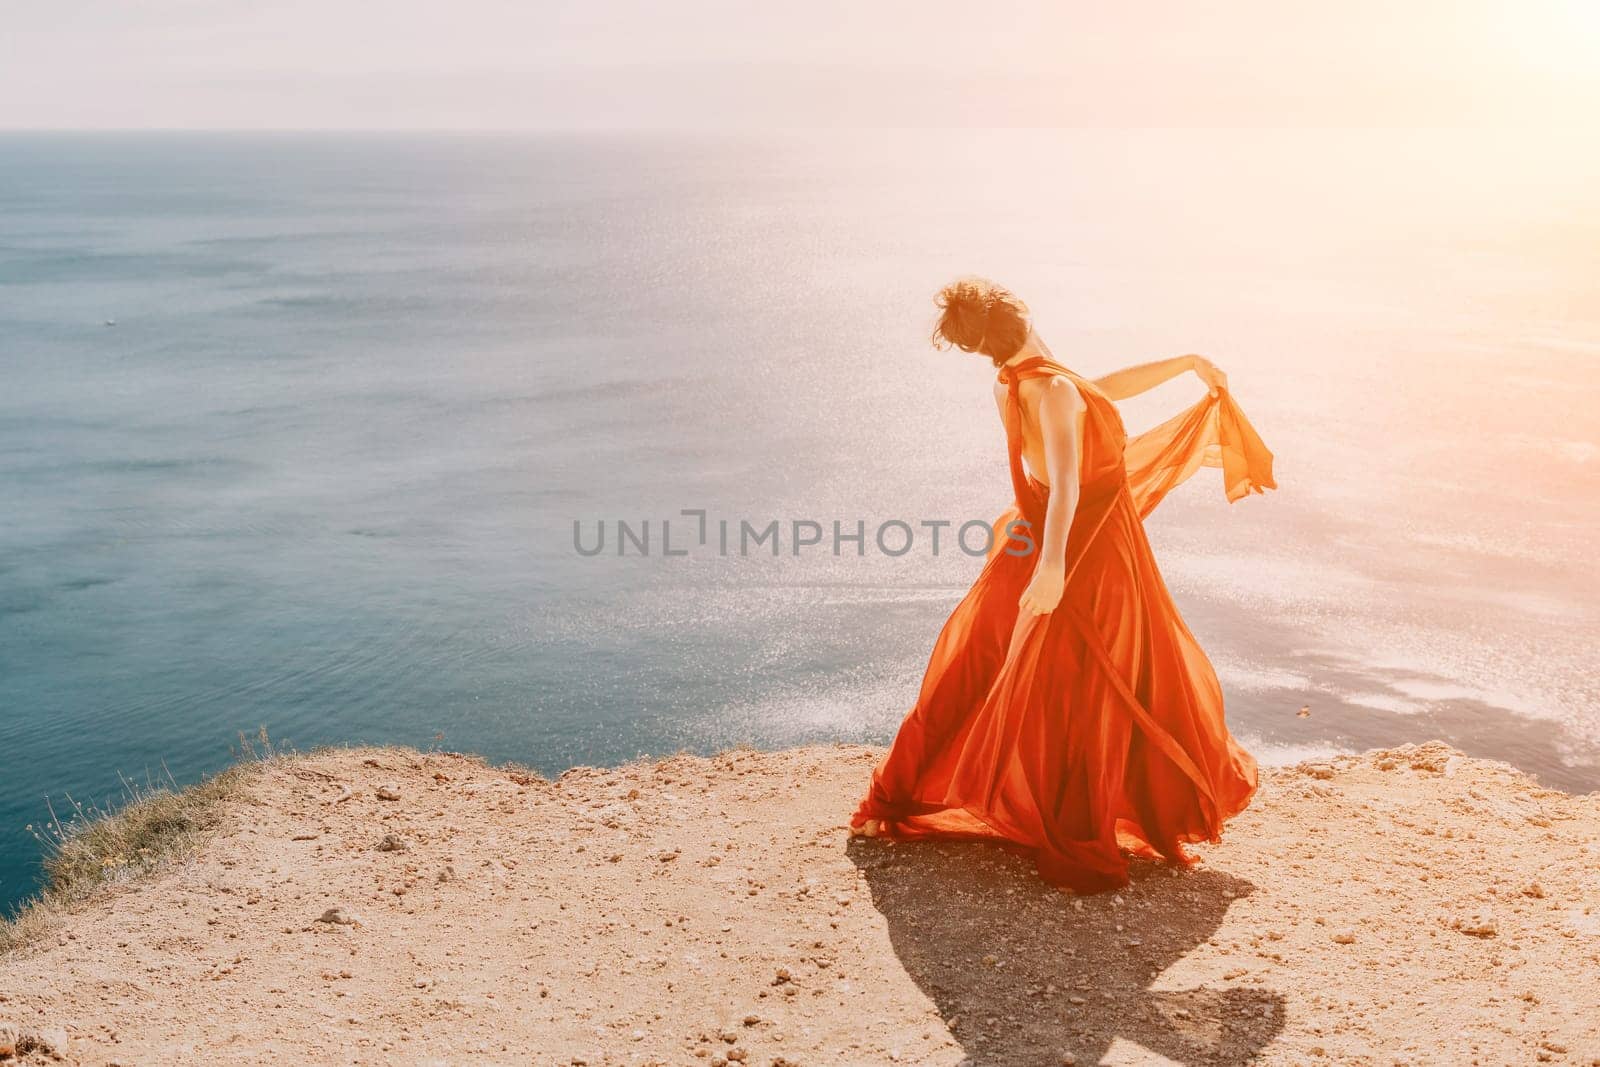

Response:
(851, 280), (1275, 893)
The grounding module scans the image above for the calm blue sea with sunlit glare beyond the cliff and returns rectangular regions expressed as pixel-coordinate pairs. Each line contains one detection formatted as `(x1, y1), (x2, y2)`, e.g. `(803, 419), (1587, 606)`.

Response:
(0, 131), (1600, 905)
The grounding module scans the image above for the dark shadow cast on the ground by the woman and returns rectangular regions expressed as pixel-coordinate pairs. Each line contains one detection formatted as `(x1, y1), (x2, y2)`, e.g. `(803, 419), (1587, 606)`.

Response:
(850, 838), (1283, 1067)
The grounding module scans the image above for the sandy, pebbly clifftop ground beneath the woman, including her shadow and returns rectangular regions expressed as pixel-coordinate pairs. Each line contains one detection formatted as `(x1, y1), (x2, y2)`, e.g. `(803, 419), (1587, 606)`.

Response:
(0, 745), (1600, 1067)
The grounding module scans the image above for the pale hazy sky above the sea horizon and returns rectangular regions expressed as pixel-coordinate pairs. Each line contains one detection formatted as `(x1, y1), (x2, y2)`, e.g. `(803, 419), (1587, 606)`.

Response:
(0, 0), (1600, 130)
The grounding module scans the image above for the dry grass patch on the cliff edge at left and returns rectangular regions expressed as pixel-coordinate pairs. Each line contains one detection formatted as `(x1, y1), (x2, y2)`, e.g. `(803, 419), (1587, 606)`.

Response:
(0, 729), (283, 953)
